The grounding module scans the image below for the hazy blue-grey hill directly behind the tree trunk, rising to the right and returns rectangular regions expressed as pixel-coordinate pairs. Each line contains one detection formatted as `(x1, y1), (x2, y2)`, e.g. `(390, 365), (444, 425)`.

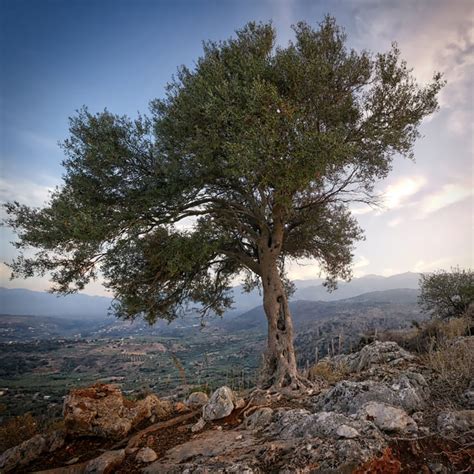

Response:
(221, 288), (426, 365)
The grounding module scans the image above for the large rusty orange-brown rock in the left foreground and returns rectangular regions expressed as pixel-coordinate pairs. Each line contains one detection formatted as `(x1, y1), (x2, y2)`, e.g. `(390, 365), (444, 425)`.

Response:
(63, 384), (173, 438)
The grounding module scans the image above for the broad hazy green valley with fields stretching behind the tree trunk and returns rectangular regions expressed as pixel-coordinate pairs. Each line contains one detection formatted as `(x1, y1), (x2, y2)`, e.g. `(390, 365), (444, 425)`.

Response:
(0, 280), (424, 420)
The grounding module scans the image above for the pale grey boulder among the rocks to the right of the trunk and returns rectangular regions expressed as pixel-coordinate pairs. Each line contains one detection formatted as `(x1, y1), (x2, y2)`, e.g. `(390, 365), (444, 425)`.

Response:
(358, 402), (418, 433)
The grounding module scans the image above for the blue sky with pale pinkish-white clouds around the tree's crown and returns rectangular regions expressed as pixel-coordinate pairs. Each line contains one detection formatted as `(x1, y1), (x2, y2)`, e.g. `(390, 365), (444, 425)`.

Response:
(0, 0), (474, 294)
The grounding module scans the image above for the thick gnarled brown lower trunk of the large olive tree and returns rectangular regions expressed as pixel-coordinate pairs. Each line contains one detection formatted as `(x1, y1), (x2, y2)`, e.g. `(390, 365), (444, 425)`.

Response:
(260, 261), (305, 389)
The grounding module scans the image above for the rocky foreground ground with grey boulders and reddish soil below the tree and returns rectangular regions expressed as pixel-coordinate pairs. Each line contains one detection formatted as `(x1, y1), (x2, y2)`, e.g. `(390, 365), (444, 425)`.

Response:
(0, 337), (474, 474)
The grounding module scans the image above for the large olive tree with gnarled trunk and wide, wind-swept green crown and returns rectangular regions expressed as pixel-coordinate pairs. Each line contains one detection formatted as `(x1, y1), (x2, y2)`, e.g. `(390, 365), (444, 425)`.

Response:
(6, 17), (443, 388)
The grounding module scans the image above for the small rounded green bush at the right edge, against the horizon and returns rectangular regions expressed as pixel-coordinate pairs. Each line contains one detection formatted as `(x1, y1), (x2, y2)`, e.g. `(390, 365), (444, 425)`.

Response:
(419, 267), (474, 319)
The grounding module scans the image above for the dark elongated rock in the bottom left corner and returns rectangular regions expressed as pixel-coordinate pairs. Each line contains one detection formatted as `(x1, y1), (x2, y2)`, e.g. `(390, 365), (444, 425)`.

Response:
(0, 430), (65, 472)
